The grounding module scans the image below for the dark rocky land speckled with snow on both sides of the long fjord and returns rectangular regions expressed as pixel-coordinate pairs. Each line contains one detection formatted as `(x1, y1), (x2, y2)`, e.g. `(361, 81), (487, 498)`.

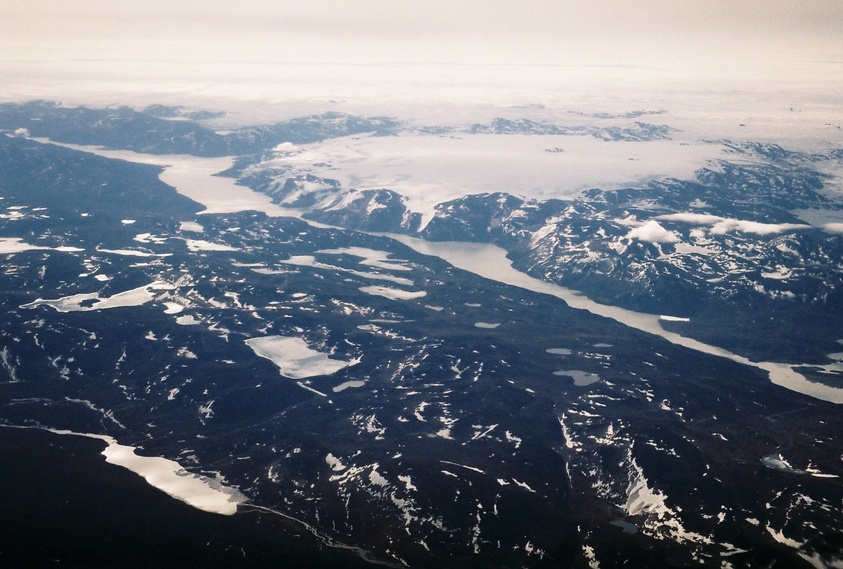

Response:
(0, 103), (843, 568)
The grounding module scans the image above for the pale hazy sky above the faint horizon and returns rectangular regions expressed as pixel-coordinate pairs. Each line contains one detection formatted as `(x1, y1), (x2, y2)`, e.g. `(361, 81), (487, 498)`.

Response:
(0, 0), (843, 64)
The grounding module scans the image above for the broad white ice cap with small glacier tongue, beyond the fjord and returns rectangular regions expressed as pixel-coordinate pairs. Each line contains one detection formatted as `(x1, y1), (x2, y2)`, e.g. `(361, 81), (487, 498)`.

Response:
(262, 133), (723, 223)
